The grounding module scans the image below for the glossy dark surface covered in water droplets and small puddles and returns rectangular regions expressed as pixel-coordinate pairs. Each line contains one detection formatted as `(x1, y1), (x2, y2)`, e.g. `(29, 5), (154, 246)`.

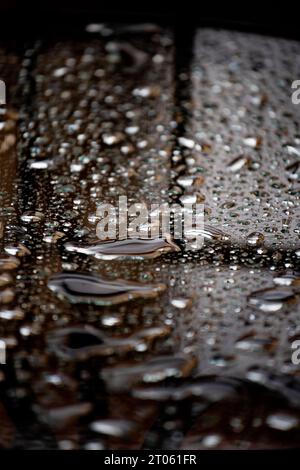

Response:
(0, 25), (300, 449)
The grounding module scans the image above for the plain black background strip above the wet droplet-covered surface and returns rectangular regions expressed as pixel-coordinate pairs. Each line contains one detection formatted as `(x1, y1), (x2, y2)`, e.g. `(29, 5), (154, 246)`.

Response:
(0, 0), (300, 40)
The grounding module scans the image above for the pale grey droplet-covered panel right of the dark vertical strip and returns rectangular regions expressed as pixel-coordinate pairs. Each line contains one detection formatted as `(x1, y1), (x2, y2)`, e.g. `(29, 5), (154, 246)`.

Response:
(188, 29), (300, 249)
